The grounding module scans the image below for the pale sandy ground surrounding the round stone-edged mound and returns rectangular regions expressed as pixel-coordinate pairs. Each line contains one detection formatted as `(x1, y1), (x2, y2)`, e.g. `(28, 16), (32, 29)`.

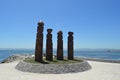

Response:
(0, 61), (120, 80)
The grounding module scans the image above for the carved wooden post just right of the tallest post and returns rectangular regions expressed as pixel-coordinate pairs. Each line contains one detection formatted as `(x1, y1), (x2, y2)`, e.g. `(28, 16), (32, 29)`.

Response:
(46, 29), (53, 61)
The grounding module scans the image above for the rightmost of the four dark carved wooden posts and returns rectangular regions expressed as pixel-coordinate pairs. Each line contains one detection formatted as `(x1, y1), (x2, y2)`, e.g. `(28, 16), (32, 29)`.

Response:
(68, 32), (74, 60)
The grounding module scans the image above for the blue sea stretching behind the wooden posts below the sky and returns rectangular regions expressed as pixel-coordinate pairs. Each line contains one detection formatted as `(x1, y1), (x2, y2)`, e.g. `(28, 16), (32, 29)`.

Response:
(0, 49), (120, 62)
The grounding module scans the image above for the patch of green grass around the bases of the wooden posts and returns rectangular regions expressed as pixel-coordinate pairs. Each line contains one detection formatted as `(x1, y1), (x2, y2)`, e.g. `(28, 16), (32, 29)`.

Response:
(24, 58), (83, 64)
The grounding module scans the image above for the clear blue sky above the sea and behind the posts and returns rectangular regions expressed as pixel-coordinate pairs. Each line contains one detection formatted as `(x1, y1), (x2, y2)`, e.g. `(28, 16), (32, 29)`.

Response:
(0, 0), (120, 49)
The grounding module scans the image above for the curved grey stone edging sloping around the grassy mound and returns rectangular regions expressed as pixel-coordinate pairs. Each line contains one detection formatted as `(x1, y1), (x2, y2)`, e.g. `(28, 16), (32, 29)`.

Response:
(15, 61), (91, 74)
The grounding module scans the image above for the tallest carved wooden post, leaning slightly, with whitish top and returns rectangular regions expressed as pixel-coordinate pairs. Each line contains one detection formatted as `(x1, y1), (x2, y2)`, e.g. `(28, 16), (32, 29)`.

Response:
(35, 21), (44, 62)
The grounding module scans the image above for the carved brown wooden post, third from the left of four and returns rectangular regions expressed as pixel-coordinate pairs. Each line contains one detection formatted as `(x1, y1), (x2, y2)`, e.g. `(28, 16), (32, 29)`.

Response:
(57, 31), (63, 60)
